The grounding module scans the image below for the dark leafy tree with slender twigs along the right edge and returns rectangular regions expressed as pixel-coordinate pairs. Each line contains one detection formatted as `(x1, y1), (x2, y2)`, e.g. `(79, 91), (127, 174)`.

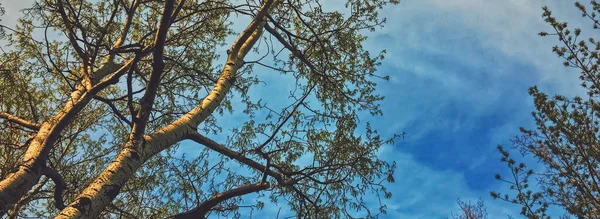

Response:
(491, 0), (600, 218)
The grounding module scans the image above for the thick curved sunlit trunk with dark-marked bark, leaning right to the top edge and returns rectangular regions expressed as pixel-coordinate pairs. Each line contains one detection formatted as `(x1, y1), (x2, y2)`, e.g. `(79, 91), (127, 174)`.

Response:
(57, 0), (281, 218)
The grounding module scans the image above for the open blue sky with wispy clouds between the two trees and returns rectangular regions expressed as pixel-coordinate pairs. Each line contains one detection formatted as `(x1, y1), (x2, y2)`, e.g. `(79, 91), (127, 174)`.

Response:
(3, 0), (590, 218)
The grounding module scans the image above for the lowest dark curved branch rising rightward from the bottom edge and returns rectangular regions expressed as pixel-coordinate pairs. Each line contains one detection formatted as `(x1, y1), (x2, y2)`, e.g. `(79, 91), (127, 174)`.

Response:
(171, 182), (269, 219)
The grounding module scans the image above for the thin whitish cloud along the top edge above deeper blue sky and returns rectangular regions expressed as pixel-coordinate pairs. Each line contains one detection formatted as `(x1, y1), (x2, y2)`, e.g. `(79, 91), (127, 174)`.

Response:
(375, 0), (591, 97)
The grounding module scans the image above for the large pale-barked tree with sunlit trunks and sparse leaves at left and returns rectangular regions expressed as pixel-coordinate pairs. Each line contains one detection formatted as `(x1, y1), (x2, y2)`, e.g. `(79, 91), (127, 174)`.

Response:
(0, 0), (398, 218)
